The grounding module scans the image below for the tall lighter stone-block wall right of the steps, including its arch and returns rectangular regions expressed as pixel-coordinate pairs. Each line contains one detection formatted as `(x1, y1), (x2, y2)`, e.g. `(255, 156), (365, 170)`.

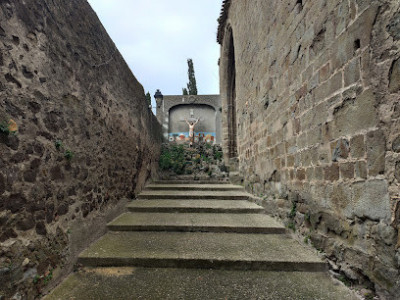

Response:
(218, 0), (400, 298)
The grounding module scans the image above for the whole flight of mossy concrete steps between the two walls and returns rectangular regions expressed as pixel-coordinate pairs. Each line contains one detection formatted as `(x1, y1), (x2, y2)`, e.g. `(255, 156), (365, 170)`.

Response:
(46, 182), (357, 299)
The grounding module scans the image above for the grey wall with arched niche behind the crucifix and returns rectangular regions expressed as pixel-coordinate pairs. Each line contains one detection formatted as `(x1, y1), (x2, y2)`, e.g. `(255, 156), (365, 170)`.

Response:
(154, 90), (221, 144)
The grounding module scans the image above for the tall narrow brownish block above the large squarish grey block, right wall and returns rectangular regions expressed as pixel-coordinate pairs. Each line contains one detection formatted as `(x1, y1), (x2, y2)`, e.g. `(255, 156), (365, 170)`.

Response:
(366, 130), (386, 176)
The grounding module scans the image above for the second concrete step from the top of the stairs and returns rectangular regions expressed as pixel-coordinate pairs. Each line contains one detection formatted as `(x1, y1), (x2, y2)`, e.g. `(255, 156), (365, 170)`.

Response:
(138, 190), (249, 200)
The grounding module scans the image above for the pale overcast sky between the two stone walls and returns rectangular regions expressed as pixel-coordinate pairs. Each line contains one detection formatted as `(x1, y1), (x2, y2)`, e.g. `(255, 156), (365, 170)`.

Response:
(88, 0), (222, 105)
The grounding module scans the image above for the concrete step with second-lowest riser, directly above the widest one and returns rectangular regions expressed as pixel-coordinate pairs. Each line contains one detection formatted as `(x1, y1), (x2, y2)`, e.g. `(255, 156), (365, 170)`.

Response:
(108, 213), (286, 234)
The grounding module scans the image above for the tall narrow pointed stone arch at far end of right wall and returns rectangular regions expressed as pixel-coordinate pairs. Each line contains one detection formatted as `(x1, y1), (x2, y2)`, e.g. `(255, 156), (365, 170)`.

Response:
(220, 25), (238, 166)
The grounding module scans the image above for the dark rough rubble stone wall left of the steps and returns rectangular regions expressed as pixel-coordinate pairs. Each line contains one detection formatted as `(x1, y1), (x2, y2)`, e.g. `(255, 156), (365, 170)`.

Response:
(0, 0), (161, 299)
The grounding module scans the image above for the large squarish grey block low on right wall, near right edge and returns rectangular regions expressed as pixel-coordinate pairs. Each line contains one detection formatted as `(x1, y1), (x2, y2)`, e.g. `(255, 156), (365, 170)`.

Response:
(352, 180), (391, 222)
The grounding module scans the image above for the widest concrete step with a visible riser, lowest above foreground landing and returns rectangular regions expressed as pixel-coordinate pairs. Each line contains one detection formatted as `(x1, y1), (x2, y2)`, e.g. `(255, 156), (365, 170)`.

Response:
(78, 231), (327, 272)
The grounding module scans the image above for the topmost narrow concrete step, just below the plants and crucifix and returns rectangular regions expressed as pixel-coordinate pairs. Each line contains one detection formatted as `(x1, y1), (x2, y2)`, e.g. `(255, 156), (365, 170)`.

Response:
(146, 184), (244, 191)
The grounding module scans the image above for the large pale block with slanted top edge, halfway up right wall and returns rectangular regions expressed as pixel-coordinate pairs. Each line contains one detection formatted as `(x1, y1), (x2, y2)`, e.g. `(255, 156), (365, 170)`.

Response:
(333, 90), (378, 136)
